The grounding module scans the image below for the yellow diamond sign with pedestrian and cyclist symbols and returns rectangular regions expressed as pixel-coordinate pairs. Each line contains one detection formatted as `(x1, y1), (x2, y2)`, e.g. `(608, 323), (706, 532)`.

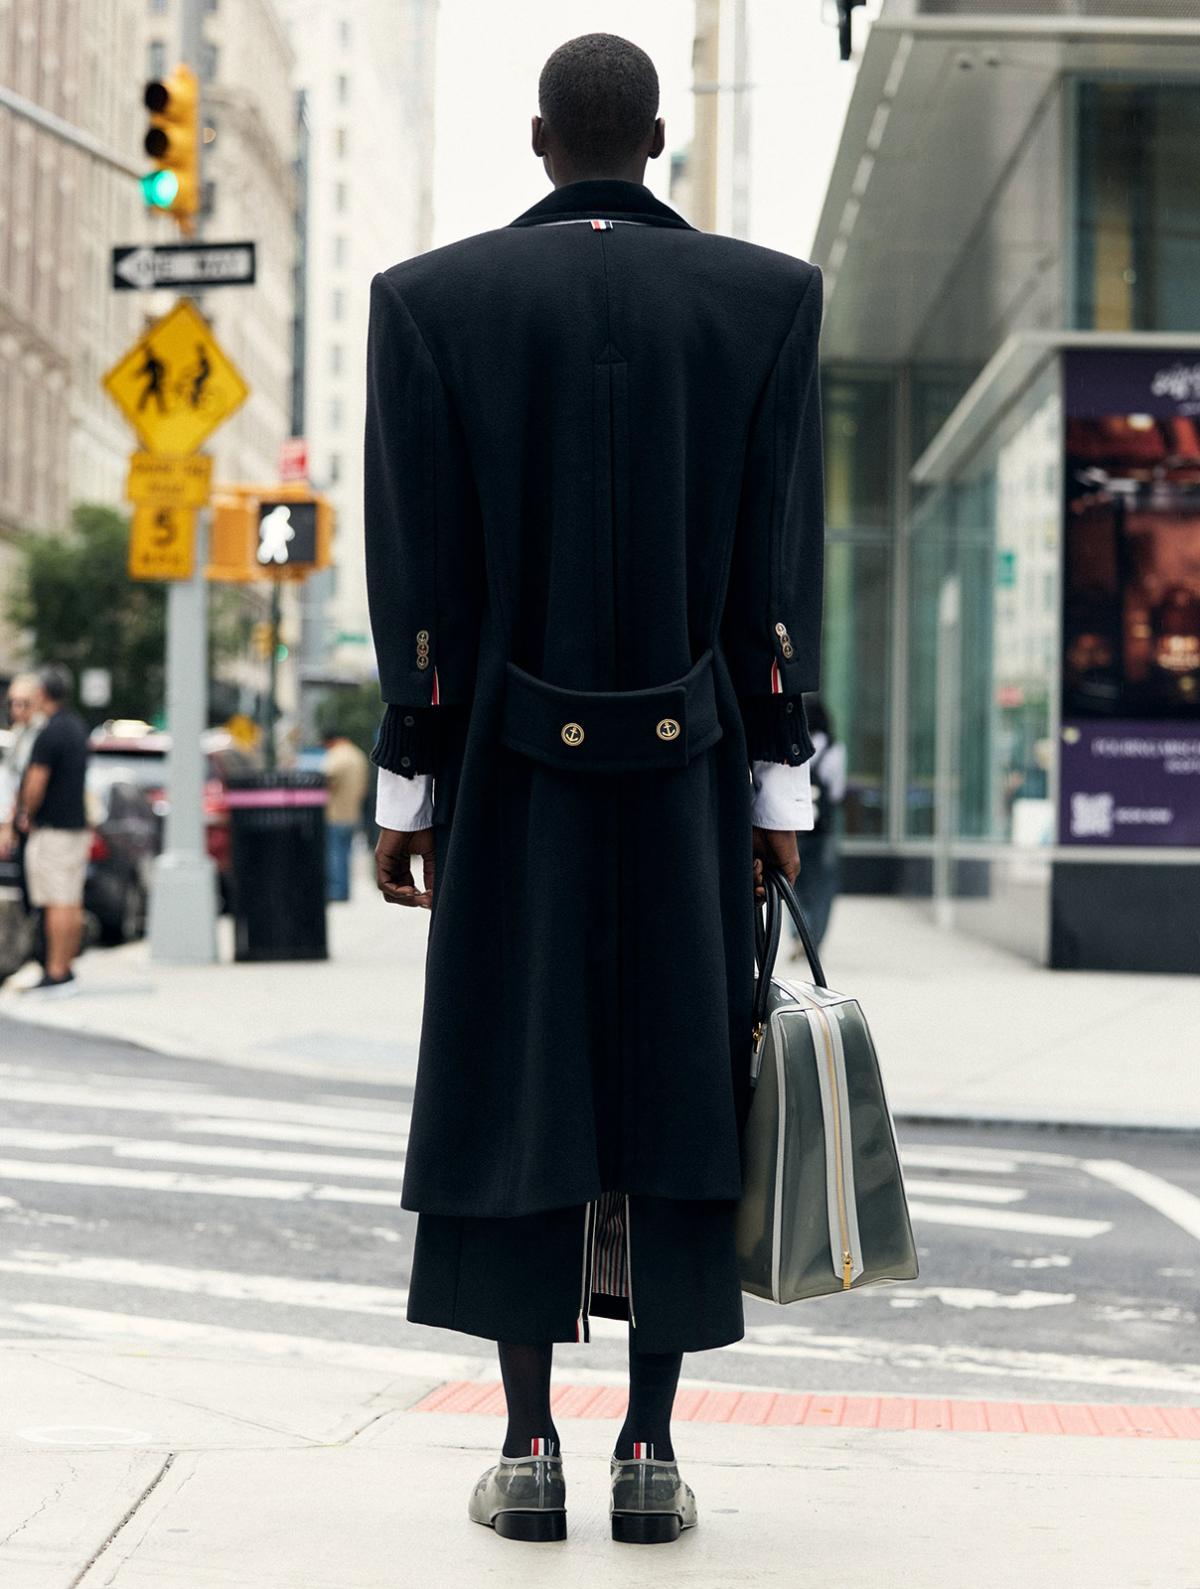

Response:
(100, 299), (250, 454)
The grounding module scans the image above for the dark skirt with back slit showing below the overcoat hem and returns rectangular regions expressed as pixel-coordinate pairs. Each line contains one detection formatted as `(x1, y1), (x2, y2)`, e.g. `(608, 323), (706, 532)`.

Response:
(408, 1192), (745, 1352)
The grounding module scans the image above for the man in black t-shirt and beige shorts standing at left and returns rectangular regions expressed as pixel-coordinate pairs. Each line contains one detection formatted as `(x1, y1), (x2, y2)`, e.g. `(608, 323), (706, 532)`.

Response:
(17, 667), (92, 992)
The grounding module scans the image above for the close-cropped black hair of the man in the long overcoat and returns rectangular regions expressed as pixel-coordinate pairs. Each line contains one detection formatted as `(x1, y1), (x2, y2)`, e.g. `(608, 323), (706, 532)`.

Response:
(537, 33), (658, 165)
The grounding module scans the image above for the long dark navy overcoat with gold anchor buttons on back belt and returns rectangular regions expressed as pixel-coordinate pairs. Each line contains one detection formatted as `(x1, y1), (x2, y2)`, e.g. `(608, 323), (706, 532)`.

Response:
(366, 181), (823, 1216)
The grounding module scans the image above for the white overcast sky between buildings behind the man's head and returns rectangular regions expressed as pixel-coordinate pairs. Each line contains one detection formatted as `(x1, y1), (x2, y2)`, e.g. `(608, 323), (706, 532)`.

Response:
(434, 0), (879, 257)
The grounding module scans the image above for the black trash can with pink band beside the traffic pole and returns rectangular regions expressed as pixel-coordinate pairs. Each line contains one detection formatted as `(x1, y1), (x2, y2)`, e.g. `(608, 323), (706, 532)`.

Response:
(226, 772), (329, 960)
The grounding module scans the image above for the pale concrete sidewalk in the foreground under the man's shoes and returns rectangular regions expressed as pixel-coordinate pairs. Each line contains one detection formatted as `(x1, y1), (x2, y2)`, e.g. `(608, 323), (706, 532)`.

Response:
(0, 1340), (1200, 1589)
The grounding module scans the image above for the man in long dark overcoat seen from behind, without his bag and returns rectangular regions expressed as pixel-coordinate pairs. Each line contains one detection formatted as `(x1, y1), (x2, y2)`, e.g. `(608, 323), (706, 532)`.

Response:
(364, 33), (823, 1545)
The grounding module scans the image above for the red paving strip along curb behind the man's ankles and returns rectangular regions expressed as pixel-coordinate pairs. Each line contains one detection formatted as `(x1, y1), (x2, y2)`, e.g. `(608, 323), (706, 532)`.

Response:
(412, 1379), (1200, 1440)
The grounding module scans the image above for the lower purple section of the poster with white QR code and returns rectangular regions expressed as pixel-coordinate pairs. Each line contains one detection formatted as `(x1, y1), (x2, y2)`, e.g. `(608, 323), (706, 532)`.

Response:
(1059, 718), (1200, 845)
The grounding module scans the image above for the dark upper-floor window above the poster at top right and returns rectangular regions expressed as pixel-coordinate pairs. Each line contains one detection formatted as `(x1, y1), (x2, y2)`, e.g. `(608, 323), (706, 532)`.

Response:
(1074, 79), (1200, 331)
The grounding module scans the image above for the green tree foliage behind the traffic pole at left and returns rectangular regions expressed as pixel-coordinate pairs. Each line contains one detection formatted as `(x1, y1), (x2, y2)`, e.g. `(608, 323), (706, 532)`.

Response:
(6, 502), (167, 720)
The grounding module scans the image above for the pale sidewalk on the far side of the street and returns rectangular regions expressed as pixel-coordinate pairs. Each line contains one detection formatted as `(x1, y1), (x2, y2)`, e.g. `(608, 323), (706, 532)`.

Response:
(0, 864), (1200, 1130)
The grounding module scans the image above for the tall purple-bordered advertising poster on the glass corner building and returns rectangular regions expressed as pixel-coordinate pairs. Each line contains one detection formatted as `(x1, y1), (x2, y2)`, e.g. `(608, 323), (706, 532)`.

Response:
(1059, 348), (1200, 845)
